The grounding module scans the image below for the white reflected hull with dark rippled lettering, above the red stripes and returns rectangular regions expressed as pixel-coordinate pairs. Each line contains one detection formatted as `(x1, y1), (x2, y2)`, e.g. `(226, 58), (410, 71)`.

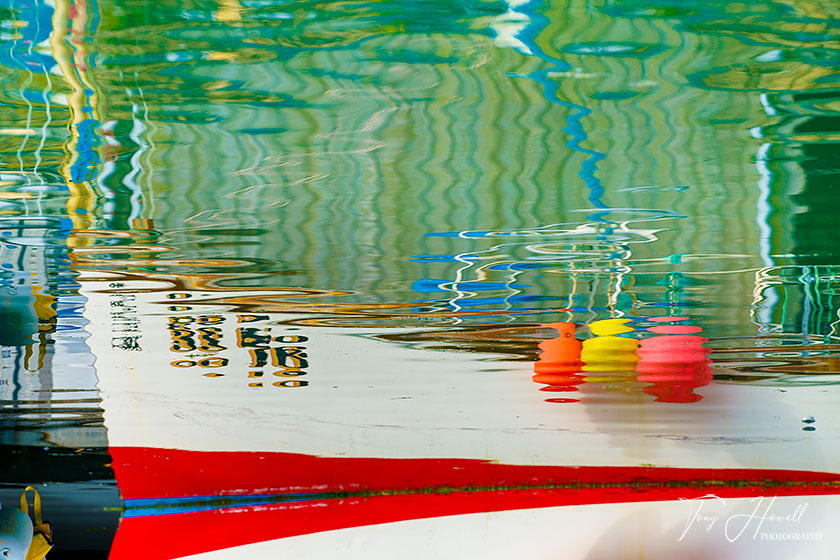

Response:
(81, 277), (840, 471)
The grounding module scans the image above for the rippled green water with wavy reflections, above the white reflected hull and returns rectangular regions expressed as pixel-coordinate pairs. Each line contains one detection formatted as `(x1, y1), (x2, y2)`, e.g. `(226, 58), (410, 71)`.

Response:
(0, 0), (840, 556)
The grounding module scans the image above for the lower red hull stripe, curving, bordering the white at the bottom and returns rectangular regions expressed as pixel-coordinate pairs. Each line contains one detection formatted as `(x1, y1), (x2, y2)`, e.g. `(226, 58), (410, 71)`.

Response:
(111, 487), (840, 560)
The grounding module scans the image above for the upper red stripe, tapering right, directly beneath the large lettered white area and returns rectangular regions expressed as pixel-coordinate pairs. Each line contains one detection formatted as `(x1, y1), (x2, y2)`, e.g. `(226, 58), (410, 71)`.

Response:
(110, 447), (840, 503)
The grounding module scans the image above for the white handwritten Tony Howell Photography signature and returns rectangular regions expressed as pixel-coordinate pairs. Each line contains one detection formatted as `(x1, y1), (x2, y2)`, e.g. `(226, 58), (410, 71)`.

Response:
(679, 494), (822, 542)
